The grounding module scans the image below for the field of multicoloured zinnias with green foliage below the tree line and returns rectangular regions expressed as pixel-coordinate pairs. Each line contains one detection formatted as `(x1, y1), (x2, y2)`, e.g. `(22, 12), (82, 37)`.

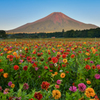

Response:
(0, 39), (100, 100)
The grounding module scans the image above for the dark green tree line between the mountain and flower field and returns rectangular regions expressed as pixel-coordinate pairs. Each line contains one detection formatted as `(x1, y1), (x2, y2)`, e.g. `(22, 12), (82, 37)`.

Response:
(0, 28), (100, 38)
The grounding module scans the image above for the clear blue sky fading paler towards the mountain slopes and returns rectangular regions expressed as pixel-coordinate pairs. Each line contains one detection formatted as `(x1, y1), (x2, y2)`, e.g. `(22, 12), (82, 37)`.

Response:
(0, 0), (100, 30)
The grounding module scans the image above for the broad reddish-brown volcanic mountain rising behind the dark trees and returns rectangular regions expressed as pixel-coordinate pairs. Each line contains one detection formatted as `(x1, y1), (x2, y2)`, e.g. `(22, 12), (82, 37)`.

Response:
(8, 12), (97, 33)
